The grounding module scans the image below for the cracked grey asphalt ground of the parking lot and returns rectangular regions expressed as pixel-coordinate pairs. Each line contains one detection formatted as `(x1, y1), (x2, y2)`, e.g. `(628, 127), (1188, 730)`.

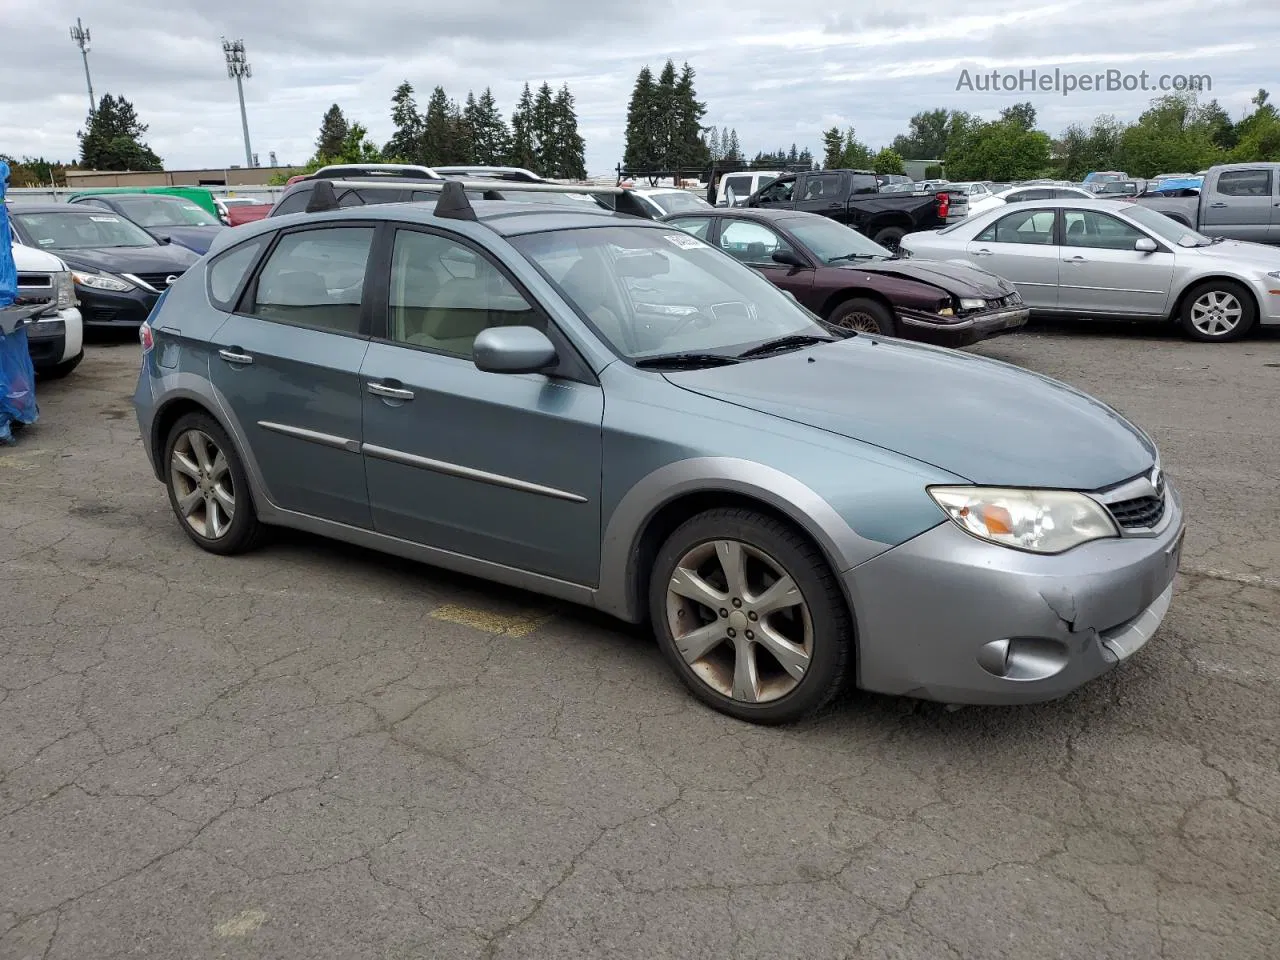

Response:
(0, 326), (1280, 960)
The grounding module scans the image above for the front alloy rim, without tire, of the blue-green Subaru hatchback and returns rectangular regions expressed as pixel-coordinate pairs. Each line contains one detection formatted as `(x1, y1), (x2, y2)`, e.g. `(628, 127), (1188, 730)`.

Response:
(667, 540), (814, 703)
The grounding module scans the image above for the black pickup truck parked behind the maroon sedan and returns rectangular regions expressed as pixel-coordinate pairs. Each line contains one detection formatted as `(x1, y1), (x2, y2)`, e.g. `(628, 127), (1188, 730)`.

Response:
(746, 170), (966, 251)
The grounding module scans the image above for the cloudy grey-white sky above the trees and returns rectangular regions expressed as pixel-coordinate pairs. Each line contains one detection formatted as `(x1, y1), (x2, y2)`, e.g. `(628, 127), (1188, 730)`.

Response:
(0, 0), (1280, 174)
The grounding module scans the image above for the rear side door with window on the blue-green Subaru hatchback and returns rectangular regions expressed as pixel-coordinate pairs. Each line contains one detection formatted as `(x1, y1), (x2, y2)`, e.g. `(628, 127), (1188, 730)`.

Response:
(210, 221), (376, 527)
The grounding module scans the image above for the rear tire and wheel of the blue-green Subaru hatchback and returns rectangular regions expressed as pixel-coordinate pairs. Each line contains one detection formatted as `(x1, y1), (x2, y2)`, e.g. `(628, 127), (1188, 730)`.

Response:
(164, 413), (265, 557)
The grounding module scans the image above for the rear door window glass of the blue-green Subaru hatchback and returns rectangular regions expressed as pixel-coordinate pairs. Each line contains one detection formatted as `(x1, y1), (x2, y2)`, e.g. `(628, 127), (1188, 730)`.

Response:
(248, 227), (374, 335)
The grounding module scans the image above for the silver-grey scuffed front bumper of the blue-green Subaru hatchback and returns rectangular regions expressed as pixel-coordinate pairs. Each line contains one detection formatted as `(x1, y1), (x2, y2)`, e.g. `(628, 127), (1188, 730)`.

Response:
(845, 484), (1185, 704)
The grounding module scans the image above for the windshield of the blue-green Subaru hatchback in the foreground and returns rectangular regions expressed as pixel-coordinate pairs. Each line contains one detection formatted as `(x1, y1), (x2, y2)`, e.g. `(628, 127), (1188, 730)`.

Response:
(511, 227), (831, 360)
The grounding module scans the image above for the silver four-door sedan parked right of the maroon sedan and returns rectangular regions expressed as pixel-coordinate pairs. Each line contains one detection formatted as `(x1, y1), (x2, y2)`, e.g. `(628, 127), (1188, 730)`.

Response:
(901, 198), (1280, 342)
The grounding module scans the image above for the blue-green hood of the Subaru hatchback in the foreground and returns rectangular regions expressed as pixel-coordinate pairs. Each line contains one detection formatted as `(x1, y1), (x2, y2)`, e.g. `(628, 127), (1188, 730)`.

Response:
(666, 334), (1156, 490)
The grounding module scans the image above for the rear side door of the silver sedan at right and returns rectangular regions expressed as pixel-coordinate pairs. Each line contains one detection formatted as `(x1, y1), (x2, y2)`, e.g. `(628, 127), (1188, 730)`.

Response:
(965, 207), (1059, 310)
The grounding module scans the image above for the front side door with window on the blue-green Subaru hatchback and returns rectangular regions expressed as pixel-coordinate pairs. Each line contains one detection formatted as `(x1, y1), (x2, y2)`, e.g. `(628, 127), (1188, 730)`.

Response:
(361, 227), (604, 585)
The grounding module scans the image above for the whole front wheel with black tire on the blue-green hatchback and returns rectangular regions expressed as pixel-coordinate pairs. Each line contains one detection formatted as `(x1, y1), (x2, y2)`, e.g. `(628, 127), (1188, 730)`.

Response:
(649, 508), (854, 724)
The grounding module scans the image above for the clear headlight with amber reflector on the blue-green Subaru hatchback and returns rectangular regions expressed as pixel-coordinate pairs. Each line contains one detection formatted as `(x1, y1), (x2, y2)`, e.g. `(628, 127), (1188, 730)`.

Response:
(928, 486), (1120, 553)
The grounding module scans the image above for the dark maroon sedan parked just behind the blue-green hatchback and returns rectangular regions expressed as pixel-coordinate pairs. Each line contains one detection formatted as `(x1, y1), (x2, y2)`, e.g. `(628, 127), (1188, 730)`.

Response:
(663, 207), (1030, 347)
